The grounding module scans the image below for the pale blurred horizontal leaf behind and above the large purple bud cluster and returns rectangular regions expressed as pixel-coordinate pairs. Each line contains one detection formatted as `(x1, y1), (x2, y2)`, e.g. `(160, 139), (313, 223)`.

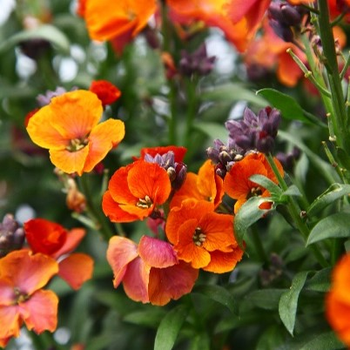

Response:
(200, 83), (267, 107)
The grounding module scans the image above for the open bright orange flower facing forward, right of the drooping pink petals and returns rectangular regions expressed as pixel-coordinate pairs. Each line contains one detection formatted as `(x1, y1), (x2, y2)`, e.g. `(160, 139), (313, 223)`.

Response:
(165, 199), (243, 273)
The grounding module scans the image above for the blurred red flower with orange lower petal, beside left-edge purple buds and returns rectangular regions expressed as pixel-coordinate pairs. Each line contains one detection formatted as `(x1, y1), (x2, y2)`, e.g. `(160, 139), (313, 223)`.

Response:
(24, 219), (94, 290)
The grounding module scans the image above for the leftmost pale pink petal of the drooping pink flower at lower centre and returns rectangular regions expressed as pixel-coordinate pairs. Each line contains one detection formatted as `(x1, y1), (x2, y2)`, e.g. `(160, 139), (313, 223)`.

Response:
(107, 236), (138, 288)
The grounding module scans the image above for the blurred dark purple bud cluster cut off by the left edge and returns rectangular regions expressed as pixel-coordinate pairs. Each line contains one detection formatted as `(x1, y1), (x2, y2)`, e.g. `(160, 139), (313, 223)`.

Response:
(0, 214), (24, 257)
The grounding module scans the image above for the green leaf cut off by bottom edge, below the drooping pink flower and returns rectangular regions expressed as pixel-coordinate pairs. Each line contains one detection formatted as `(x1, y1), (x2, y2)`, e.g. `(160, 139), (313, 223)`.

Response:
(154, 305), (188, 350)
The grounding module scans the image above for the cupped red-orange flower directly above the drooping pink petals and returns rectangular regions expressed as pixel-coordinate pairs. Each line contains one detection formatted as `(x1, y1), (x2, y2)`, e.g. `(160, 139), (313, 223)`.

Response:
(102, 160), (171, 222)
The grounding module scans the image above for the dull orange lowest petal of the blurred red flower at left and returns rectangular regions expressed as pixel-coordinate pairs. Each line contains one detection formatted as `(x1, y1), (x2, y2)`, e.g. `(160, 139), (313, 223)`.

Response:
(58, 253), (94, 290)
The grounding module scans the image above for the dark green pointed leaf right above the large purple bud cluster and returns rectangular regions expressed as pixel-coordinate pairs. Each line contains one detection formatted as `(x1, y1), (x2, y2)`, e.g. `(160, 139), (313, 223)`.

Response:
(256, 88), (323, 126)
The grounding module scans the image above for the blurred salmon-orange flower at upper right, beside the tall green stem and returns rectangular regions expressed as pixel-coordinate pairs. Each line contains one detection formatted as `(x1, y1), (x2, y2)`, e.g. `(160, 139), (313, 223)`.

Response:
(244, 22), (306, 87)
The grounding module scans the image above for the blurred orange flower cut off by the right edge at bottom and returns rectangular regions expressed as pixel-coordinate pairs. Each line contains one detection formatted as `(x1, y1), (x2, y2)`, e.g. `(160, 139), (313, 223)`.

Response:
(326, 254), (350, 347)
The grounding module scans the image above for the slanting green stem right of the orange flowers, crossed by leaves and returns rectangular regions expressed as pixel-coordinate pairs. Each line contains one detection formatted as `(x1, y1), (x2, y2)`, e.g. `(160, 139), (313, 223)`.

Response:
(266, 154), (329, 267)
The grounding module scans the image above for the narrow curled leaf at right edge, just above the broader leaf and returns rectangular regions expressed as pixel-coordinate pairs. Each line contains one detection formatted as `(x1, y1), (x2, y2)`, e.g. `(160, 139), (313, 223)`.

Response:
(307, 183), (350, 216)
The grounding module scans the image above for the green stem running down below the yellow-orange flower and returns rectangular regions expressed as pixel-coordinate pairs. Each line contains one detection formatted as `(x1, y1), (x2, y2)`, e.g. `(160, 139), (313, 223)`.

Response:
(80, 175), (114, 241)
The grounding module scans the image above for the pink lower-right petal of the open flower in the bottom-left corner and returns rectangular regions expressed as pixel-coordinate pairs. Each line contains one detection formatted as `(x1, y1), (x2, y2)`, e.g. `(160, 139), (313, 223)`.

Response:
(19, 290), (58, 334)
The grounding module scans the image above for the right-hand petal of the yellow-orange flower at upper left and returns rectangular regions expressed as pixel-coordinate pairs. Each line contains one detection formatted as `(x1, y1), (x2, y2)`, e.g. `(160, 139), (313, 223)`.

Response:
(84, 119), (125, 172)
